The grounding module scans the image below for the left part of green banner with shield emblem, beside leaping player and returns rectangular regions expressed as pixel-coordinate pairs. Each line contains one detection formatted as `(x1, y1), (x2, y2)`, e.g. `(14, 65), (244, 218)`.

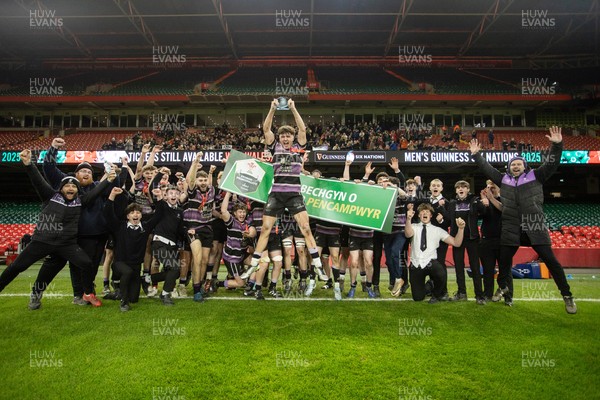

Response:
(219, 150), (273, 203)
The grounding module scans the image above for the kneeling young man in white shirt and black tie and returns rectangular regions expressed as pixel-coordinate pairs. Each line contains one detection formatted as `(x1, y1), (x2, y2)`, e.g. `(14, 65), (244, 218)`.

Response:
(404, 203), (465, 304)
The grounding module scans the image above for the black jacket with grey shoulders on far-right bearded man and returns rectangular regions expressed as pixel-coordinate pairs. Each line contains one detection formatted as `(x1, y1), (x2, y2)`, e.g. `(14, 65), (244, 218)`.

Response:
(473, 142), (563, 246)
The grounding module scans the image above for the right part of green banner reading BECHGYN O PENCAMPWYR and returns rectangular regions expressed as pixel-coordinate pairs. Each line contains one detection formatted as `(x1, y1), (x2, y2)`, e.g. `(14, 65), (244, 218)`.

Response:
(300, 175), (397, 233)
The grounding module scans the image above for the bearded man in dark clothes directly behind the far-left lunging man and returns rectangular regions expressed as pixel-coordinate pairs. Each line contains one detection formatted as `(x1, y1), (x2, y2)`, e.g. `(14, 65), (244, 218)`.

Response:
(41, 138), (127, 305)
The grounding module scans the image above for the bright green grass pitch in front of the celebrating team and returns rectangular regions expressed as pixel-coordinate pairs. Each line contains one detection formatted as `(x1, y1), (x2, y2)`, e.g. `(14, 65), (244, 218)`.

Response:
(0, 264), (600, 400)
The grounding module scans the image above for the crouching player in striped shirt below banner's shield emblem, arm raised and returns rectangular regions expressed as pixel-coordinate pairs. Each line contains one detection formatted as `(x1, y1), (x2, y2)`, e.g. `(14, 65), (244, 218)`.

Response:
(217, 192), (258, 293)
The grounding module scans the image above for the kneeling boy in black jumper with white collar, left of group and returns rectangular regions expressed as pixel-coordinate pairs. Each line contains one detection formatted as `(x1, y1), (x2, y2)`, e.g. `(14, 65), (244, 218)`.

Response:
(104, 188), (163, 311)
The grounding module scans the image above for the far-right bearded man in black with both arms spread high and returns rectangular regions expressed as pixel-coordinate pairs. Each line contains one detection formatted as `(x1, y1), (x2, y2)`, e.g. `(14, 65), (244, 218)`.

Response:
(470, 126), (577, 314)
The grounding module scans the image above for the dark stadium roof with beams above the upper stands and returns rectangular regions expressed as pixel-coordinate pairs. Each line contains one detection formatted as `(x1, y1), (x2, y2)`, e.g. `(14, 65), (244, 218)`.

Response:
(0, 0), (600, 68)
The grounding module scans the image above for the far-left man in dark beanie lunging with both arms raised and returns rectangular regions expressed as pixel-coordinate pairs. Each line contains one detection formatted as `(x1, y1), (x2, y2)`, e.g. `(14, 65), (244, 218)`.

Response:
(0, 150), (116, 310)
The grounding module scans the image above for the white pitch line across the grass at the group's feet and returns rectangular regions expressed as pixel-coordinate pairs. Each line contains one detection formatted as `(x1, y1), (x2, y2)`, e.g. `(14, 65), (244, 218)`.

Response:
(0, 293), (600, 304)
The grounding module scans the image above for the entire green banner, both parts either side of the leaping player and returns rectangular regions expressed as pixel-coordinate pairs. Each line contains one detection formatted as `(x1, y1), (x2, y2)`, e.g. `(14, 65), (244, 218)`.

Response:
(220, 150), (397, 233)
